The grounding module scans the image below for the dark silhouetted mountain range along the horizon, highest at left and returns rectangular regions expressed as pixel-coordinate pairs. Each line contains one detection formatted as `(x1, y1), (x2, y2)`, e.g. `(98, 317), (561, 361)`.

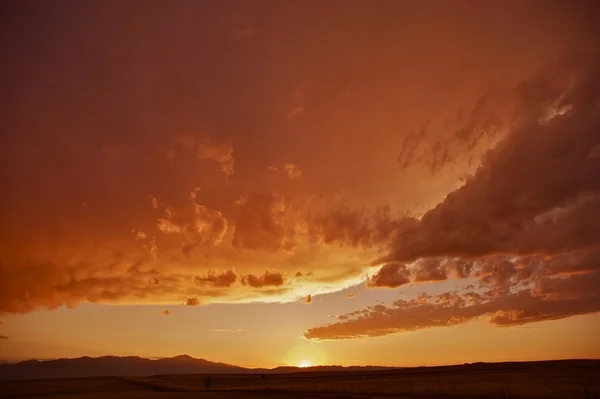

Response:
(0, 355), (387, 381)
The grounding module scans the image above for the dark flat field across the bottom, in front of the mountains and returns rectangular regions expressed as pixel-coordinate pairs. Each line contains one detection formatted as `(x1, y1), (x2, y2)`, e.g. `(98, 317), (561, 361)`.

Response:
(0, 361), (600, 399)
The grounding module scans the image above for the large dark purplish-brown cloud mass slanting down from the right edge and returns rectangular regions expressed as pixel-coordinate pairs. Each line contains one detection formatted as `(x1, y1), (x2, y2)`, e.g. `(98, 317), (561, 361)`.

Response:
(305, 56), (600, 339)
